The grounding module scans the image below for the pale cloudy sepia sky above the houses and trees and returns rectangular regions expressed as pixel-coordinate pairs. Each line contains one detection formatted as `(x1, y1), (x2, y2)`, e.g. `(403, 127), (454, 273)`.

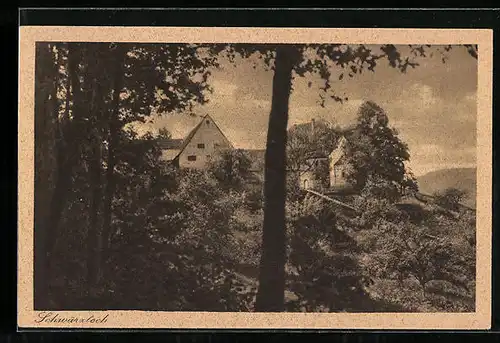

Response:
(133, 46), (477, 176)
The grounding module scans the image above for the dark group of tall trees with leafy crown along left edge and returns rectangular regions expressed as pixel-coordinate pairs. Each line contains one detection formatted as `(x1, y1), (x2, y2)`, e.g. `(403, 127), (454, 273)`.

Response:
(35, 43), (215, 308)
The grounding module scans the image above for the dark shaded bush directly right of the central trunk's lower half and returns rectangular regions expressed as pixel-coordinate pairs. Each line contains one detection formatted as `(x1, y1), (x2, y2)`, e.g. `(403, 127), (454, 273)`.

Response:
(288, 198), (364, 312)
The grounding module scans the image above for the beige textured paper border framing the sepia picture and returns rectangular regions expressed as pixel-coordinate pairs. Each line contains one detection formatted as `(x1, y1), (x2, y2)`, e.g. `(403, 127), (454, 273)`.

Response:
(18, 26), (493, 329)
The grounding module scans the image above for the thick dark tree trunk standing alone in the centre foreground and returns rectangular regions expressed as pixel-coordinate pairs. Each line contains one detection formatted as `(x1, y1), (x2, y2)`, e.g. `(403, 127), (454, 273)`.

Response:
(255, 45), (296, 312)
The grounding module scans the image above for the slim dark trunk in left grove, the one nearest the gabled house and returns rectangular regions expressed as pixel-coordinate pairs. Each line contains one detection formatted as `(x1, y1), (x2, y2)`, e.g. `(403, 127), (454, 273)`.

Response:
(102, 45), (125, 276)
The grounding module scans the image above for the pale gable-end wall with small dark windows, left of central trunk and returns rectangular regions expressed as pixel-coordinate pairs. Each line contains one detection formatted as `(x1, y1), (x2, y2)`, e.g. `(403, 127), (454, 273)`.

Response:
(179, 117), (231, 169)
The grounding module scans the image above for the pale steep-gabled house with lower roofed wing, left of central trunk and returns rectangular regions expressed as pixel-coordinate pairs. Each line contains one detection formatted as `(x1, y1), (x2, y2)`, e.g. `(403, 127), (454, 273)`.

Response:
(161, 114), (233, 169)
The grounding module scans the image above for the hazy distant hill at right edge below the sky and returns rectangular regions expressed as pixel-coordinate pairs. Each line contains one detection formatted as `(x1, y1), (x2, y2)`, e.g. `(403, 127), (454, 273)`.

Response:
(417, 168), (476, 208)
